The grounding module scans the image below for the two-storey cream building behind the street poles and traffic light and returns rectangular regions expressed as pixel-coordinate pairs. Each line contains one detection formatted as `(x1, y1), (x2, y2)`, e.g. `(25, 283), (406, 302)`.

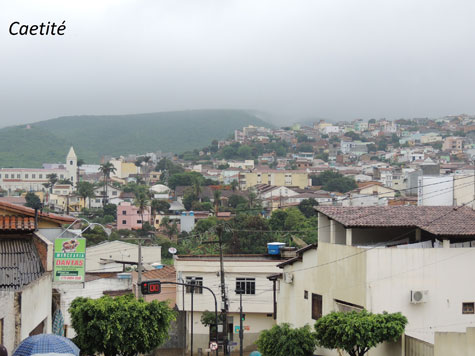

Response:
(175, 255), (282, 352)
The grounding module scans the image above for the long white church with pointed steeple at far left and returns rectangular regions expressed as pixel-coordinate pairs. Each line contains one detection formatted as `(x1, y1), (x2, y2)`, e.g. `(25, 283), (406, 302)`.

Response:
(0, 147), (78, 195)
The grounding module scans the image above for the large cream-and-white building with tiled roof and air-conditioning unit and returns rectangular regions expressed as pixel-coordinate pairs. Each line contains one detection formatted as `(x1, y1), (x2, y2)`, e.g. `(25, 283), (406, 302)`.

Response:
(277, 206), (475, 356)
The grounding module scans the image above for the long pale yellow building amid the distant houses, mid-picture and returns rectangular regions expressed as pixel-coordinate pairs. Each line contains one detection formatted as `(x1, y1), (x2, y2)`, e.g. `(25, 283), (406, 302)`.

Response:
(239, 169), (311, 190)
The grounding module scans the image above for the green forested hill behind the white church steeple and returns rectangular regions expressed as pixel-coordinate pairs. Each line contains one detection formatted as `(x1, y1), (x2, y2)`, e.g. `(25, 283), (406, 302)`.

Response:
(0, 110), (270, 167)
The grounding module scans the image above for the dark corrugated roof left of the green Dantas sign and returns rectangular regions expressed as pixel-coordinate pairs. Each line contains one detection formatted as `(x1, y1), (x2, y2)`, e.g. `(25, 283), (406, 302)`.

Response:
(0, 237), (44, 290)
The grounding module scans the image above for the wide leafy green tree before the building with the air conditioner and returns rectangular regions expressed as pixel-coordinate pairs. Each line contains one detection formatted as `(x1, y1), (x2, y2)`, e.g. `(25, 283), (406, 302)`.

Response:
(315, 310), (407, 356)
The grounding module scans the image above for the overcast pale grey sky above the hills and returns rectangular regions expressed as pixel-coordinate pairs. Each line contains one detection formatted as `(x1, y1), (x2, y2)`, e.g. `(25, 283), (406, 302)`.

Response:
(0, 0), (475, 126)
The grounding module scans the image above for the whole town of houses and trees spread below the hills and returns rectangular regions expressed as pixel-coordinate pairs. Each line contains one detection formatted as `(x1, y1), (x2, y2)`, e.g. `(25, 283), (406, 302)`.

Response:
(0, 114), (475, 356)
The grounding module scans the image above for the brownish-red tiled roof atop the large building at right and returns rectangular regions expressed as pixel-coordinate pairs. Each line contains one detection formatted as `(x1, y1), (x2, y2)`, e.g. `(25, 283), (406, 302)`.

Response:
(316, 205), (475, 236)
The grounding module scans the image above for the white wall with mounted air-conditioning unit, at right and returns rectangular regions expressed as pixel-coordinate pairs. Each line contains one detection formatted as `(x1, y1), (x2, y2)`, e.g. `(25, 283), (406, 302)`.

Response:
(368, 248), (475, 343)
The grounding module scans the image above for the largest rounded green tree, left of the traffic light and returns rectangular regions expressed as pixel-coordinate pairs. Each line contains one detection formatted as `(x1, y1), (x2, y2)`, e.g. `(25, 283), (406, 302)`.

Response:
(69, 294), (175, 356)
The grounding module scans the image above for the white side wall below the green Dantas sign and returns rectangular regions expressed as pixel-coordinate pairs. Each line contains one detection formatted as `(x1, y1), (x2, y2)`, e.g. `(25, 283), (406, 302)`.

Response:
(20, 273), (52, 340)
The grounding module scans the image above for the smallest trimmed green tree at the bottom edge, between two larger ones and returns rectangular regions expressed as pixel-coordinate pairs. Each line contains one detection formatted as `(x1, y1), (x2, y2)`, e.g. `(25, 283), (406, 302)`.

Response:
(256, 323), (316, 356)
